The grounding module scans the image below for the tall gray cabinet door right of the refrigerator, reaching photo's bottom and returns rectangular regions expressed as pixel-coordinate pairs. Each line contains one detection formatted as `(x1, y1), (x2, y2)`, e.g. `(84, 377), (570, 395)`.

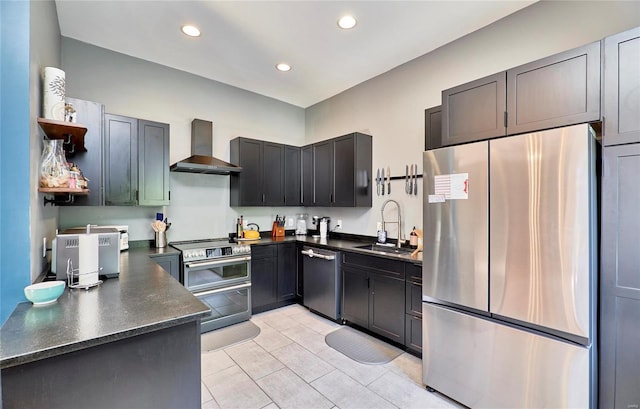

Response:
(599, 144), (640, 408)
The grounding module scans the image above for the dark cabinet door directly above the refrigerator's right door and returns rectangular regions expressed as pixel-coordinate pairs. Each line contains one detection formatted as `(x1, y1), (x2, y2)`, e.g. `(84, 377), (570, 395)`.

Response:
(507, 42), (600, 135)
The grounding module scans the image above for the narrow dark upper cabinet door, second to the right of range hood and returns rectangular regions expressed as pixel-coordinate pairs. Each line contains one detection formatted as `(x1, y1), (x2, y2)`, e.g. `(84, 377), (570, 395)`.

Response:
(262, 142), (284, 206)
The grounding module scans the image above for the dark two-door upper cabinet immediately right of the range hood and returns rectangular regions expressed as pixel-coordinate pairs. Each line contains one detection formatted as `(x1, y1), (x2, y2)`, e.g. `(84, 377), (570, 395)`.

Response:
(229, 137), (284, 206)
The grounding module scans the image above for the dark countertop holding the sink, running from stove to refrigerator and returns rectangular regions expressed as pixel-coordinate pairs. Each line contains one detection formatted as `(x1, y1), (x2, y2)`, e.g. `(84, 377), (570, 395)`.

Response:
(245, 235), (422, 265)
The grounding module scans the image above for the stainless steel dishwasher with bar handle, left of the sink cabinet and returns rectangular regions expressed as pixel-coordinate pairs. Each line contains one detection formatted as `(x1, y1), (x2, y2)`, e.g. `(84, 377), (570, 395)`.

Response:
(301, 246), (342, 320)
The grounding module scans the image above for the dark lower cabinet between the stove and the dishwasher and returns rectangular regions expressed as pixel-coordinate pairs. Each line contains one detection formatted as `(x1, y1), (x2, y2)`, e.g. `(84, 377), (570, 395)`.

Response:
(251, 242), (298, 313)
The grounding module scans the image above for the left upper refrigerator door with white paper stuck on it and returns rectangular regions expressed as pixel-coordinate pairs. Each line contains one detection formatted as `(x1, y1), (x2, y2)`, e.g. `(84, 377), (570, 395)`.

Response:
(422, 141), (489, 312)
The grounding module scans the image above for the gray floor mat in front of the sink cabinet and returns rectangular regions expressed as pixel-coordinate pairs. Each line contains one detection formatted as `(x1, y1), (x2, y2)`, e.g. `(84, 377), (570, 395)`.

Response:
(325, 327), (402, 365)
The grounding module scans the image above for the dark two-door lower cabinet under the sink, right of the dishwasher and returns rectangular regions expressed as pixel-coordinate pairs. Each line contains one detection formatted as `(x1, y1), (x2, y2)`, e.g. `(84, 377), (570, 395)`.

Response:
(341, 253), (405, 344)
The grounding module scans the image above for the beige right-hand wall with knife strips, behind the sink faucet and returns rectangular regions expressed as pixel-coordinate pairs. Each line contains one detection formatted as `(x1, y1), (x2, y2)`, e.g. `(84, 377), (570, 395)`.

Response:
(305, 1), (640, 237)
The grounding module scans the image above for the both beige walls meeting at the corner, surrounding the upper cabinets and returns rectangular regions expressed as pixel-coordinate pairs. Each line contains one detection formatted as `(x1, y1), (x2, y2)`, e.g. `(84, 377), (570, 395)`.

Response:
(60, 1), (640, 241)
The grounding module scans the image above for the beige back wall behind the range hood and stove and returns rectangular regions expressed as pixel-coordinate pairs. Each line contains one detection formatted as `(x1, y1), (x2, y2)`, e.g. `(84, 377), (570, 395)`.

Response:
(60, 38), (304, 241)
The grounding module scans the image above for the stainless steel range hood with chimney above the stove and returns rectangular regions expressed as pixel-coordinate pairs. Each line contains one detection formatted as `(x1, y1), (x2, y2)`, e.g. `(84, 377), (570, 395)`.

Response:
(170, 119), (242, 175)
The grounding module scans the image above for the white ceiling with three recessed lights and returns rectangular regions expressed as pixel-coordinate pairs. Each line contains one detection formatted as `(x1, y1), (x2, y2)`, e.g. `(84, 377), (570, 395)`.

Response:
(56, 0), (535, 108)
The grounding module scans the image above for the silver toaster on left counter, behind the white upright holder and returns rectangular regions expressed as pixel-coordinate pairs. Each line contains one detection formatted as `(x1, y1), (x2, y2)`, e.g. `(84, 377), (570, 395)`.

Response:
(51, 227), (120, 280)
